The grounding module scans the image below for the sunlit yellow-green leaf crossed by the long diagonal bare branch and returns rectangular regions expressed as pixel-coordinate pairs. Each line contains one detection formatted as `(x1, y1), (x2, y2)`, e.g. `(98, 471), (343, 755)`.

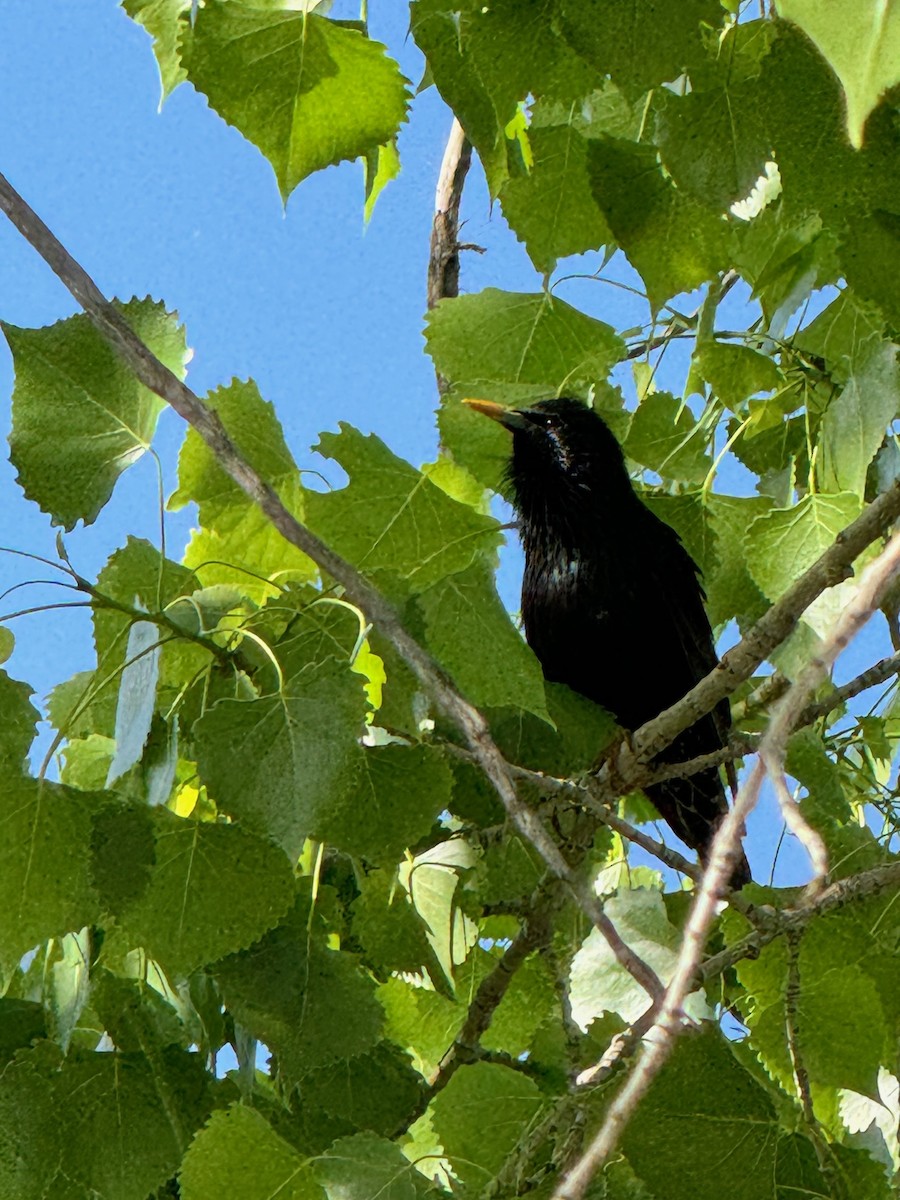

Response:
(168, 379), (318, 602)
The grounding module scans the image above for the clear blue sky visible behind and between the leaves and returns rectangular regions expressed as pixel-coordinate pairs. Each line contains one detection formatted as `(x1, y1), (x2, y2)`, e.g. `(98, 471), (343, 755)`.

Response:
(0, 0), (888, 882)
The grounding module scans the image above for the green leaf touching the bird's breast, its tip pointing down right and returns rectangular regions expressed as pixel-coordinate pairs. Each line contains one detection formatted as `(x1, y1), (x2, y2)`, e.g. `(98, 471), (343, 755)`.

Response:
(418, 564), (550, 721)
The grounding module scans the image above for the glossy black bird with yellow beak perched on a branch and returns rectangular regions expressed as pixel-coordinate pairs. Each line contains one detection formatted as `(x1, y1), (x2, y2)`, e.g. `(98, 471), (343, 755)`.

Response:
(466, 398), (750, 887)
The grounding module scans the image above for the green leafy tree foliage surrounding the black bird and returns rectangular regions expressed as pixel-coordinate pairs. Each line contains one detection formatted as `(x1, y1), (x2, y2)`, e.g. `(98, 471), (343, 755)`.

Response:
(0, 0), (900, 1200)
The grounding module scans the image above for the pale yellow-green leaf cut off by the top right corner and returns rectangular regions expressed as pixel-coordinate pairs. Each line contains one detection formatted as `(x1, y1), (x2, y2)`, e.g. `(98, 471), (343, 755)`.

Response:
(778, 0), (900, 149)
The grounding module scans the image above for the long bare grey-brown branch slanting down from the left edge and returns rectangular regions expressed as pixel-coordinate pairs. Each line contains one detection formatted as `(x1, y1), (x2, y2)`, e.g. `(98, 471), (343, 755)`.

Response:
(0, 175), (662, 998)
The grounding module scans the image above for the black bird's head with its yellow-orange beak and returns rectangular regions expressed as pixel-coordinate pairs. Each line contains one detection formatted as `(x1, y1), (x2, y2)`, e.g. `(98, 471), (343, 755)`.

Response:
(464, 397), (631, 511)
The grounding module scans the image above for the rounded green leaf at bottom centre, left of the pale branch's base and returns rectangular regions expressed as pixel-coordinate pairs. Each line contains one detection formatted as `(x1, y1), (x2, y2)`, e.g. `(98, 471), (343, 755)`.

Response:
(431, 1062), (542, 1189)
